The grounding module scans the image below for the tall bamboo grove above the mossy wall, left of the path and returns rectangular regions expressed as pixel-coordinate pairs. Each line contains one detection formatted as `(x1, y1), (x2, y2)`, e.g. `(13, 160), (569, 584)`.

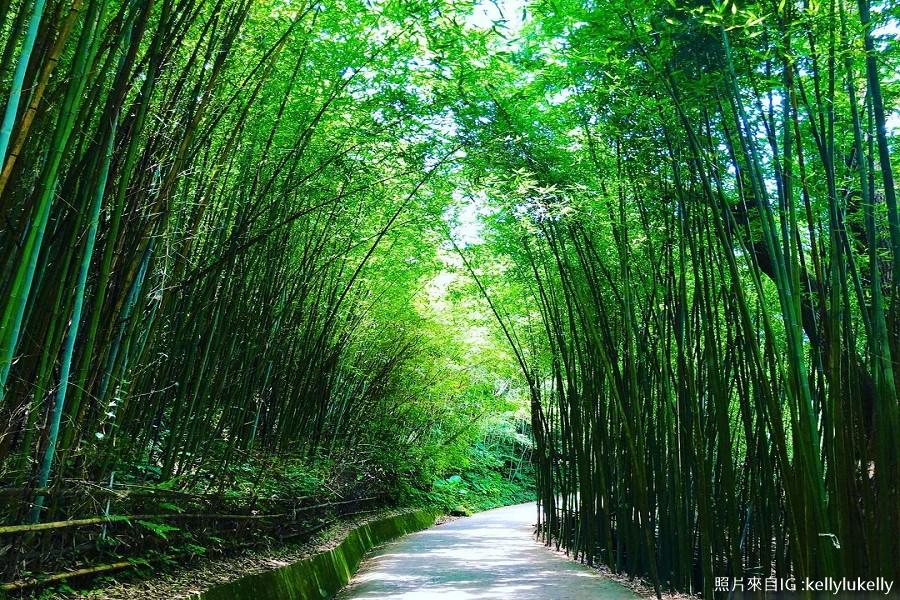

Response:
(0, 0), (450, 521)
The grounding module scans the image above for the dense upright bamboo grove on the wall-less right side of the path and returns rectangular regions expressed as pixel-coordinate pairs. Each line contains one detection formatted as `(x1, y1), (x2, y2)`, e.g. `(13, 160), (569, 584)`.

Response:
(461, 0), (900, 597)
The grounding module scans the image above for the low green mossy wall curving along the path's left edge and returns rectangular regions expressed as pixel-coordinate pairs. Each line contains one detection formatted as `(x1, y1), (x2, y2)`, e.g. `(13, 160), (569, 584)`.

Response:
(199, 511), (435, 600)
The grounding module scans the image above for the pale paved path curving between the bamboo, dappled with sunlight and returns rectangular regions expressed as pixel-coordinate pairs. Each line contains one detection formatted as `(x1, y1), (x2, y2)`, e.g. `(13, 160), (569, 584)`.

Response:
(336, 504), (637, 600)
